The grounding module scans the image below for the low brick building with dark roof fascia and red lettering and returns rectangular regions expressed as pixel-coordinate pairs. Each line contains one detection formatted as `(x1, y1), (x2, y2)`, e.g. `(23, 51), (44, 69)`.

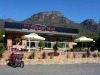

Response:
(4, 22), (78, 51)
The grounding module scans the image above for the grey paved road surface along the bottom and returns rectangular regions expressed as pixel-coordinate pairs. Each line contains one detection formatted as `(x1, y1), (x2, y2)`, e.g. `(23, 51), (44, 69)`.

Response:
(0, 64), (100, 75)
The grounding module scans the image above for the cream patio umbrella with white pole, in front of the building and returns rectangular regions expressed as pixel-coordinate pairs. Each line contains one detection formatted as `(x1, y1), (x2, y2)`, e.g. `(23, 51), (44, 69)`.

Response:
(22, 33), (45, 52)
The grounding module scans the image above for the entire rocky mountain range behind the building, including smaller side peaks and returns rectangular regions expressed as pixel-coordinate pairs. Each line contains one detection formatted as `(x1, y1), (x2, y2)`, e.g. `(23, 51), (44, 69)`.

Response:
(0, 11), (100, 34)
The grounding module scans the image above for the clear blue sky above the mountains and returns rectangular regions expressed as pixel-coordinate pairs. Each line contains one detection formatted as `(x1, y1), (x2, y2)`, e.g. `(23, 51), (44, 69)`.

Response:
(0, 0), (100, 23)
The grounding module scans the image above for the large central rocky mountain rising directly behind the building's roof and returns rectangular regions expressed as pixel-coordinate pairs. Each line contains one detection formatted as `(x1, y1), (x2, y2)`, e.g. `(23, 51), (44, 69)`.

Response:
(23, 11), (96, 34)
